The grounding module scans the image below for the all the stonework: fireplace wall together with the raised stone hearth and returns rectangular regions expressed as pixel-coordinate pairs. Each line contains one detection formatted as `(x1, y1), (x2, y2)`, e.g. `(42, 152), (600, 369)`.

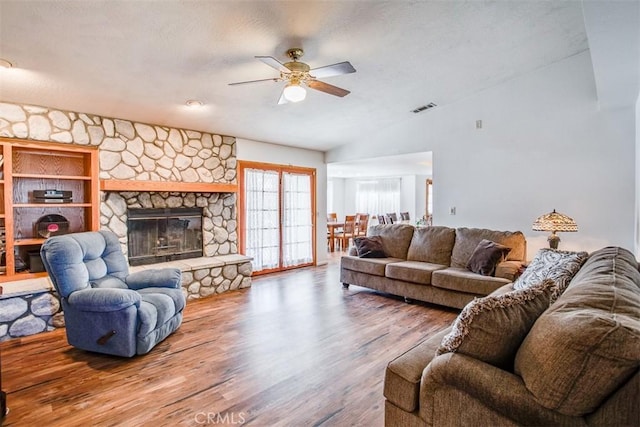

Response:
(0, 102), (251, 339)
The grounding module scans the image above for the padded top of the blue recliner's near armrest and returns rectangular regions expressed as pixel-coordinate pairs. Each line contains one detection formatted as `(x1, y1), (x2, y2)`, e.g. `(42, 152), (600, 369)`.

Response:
(67, 288), (141, 313)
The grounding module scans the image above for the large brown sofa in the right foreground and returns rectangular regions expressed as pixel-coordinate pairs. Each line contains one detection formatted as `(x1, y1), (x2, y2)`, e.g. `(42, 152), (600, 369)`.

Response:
(384, 247), (640, 427)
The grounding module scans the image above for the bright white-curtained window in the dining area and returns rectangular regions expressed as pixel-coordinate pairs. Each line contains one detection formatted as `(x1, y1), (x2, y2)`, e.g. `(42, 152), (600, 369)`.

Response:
(356, 178), (400, 215)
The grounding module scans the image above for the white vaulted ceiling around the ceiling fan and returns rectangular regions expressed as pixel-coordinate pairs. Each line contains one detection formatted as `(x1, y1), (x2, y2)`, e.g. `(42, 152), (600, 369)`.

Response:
(0, 0), (588, 151)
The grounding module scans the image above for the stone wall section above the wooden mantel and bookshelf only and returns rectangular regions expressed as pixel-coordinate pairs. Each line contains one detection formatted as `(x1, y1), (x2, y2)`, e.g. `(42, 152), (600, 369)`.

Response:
(0, 103), (236, 183)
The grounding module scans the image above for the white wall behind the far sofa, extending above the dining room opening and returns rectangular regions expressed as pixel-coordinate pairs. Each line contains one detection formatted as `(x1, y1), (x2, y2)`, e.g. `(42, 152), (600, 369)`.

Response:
(326, 52), (636, 257)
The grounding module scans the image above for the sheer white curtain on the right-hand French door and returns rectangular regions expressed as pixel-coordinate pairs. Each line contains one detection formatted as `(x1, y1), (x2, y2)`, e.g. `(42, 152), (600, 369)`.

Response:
(282, 172), (313, 267)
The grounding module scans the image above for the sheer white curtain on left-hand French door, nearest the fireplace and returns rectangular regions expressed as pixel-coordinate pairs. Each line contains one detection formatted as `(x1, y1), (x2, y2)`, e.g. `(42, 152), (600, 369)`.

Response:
(244, 169), (280, 271)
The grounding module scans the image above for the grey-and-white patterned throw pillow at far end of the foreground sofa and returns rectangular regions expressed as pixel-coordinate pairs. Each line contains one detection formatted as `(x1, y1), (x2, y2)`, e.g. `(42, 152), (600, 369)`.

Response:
(513, 248), (589, 302)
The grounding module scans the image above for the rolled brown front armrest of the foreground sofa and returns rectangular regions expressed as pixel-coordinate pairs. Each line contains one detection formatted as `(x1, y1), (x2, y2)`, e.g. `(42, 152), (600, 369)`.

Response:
(420, 353), (584, 425)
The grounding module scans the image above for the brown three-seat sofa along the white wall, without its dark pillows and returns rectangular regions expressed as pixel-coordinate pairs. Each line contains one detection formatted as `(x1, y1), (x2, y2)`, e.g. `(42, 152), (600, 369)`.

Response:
(340, 224), (527, 308)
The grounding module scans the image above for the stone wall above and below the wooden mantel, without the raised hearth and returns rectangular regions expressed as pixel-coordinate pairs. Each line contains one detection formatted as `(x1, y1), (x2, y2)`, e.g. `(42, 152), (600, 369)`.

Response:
(0, 103), (238, 256)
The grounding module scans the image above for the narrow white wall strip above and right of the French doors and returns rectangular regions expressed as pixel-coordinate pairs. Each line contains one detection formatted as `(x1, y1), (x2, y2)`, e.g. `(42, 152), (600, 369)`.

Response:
(236, 138), (327, 265)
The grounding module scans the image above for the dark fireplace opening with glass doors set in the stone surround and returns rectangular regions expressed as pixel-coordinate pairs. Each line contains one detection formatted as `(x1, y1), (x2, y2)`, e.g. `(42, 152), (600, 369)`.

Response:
(127, 208), (202, 265)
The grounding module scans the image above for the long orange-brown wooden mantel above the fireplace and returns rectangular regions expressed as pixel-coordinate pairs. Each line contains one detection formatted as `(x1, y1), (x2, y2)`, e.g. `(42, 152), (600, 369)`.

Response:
(100, 179), (238, 193)
